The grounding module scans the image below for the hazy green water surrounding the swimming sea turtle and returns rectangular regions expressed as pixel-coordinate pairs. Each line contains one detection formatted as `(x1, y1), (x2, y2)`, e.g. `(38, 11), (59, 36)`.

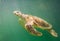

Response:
(0, 0), (60, 41)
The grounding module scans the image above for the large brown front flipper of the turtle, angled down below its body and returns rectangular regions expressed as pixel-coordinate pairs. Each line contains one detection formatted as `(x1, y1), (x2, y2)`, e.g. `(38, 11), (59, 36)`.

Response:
(25, 22), (42, 36)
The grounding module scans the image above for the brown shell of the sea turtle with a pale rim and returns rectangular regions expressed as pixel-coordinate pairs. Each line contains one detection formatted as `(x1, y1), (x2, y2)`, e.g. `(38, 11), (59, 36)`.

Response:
(33, 17), (52, 29)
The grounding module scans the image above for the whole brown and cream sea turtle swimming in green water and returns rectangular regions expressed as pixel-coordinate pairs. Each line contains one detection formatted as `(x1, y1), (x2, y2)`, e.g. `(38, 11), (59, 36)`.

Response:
(13, 11), (58, 37)
